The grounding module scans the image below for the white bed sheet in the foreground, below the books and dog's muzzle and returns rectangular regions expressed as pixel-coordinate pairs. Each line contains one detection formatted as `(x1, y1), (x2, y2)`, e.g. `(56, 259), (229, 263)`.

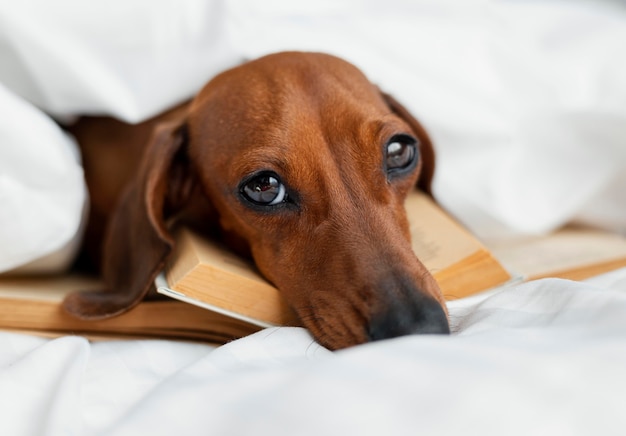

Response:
(0, 269), (626, 436)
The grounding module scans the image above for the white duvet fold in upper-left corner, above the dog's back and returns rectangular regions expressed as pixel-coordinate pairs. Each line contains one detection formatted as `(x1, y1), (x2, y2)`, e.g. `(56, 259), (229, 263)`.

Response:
(0, 0), (241, 122)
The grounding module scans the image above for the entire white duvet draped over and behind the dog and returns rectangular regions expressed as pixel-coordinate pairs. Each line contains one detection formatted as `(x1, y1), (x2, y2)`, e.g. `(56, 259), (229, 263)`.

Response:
(0, 0), (626, 271)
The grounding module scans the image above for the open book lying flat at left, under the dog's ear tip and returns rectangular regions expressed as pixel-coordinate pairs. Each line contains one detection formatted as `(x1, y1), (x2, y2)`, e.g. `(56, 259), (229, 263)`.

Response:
(0, 275), (260, 344)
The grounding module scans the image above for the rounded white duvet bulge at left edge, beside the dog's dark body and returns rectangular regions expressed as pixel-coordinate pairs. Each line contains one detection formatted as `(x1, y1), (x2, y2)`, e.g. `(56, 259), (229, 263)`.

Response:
(0, 84), (86, 272)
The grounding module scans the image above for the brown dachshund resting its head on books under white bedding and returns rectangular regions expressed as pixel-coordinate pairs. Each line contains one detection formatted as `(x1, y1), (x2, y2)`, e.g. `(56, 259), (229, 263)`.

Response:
(65, 52), (449, 349)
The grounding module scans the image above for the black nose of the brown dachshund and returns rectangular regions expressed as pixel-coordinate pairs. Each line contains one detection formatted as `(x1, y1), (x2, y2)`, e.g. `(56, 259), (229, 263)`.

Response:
(367, 293), (450, 341)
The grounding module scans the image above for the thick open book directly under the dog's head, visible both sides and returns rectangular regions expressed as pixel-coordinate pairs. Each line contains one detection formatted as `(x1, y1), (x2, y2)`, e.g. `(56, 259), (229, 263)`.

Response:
(158, 190), (511, 326)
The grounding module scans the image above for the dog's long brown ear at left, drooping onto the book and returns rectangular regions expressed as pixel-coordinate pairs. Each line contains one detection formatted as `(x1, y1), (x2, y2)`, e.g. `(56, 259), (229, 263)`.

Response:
(63, 122), (193, 320)
